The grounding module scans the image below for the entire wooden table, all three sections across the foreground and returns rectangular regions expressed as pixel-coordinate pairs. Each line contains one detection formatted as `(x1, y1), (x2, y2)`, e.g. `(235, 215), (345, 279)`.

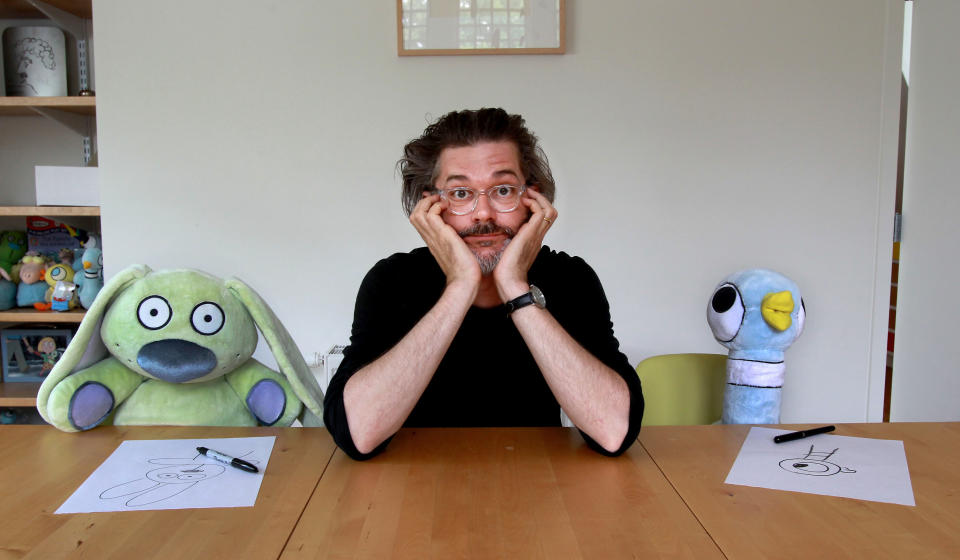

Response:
(0, 423), (960, 560)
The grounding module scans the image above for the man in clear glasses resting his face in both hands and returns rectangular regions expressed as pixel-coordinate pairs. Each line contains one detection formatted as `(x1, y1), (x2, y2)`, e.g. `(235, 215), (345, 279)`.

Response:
(324, 109), (643, 459)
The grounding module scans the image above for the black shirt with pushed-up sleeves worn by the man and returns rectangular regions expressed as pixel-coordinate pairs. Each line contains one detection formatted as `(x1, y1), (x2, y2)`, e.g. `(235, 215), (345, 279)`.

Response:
(324, 246), (644, 459)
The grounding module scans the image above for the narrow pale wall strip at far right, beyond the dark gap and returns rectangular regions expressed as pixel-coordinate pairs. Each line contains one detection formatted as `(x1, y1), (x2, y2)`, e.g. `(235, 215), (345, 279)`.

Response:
(890, 0), (960, 421)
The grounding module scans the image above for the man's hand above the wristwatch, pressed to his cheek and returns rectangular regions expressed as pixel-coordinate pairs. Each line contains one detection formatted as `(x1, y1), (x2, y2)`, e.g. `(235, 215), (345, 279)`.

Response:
(493, 189), (557, 302)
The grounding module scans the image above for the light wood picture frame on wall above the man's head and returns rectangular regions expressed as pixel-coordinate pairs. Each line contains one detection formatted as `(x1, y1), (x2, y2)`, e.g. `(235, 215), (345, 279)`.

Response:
(397, 0), (566, 56)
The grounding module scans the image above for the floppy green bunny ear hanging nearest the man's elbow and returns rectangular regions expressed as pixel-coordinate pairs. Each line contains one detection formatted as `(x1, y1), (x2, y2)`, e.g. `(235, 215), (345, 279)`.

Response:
(225, 278), (323, 418)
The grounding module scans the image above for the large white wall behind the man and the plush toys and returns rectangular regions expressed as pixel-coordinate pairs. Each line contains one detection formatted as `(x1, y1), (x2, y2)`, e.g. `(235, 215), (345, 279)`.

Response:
(94, 0), (902, 421)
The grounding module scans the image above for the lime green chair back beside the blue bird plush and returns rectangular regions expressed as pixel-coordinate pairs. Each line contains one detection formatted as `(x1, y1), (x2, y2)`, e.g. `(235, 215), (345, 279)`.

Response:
(637, 354), (727, 426)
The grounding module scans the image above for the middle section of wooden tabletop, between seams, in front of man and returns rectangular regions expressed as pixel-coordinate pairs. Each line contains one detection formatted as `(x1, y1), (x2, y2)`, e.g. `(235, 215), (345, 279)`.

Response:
(282, 428), (723, 559)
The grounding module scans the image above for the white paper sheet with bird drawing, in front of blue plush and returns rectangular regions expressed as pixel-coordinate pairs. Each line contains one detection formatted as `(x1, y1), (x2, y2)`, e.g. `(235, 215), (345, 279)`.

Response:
(725, 427), (916, 506)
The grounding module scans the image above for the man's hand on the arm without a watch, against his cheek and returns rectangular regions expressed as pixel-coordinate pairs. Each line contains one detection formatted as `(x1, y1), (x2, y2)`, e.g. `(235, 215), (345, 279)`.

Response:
(410, 193), (481, 294)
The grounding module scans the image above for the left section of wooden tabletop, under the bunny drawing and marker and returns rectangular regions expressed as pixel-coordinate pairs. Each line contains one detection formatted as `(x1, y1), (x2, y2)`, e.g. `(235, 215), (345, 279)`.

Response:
(0, 426), (335, 560)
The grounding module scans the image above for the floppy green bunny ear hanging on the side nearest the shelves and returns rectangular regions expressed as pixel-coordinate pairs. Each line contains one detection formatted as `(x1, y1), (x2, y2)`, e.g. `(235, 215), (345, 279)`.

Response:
(37, 264), (151, 424)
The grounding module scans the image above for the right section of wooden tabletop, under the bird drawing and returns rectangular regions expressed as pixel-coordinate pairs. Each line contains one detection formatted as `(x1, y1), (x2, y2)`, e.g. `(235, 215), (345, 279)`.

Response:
(640, 422), (960, 560)
